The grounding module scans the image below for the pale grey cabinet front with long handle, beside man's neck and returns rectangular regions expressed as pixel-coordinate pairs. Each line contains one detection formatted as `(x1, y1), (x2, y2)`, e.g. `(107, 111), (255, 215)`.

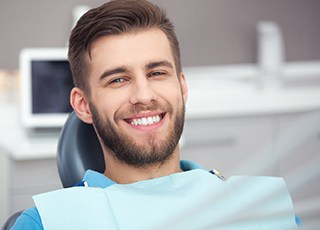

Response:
(181, 117), (278, 176)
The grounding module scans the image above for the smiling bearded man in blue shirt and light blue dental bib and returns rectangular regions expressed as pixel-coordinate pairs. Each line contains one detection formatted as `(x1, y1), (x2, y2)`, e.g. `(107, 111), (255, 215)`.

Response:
(10, 0), (295, 229)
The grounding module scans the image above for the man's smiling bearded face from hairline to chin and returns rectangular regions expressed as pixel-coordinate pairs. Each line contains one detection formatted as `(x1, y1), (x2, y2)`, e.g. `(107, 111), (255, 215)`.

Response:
(85, 29), (187, 167)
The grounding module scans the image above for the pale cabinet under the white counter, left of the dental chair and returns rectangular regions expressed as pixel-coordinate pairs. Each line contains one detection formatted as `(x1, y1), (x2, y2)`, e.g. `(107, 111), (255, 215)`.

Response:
(0, 154), (62, 225)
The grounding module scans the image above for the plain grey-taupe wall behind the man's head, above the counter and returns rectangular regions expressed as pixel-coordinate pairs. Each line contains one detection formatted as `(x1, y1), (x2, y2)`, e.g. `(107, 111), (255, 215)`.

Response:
(0, 0), (320, 70)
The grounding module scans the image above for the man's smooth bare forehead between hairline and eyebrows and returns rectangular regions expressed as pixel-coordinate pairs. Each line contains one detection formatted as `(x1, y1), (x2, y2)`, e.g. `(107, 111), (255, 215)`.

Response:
(88, 29), (174, 71)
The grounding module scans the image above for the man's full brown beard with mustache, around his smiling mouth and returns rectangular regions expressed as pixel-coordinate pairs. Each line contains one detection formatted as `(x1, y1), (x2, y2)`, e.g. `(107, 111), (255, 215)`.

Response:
(89, 99), (185, 167)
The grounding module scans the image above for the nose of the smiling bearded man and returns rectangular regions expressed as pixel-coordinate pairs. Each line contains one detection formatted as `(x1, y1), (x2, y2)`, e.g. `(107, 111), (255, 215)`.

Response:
(130, 77), (156, 105)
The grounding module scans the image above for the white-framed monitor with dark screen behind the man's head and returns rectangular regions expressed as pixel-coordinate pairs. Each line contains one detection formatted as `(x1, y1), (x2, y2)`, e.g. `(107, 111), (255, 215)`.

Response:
(20, 48), (73, 128)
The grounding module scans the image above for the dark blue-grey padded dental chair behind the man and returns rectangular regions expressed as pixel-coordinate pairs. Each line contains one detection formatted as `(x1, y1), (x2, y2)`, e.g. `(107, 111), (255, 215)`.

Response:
(1, 112), (105, 230)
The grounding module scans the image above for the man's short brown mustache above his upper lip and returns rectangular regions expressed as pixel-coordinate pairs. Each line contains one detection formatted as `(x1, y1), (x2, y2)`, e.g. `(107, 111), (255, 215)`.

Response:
(115, 102), (173, 119)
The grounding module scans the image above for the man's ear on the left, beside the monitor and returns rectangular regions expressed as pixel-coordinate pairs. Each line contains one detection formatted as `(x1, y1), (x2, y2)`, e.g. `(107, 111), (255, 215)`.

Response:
(70, 87), (92, 124)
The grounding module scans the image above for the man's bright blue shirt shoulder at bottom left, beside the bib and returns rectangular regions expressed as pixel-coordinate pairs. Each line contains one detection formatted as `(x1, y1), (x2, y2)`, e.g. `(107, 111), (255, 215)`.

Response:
(12, 207), (43, 230)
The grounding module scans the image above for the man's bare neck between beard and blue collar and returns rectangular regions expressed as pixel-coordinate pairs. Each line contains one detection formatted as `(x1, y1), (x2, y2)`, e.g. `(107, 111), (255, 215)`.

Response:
(104, 147), (181, 184)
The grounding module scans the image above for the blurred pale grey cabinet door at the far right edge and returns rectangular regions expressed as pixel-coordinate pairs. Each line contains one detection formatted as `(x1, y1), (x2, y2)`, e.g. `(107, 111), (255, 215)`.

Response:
(275, 111), (320, 226)
